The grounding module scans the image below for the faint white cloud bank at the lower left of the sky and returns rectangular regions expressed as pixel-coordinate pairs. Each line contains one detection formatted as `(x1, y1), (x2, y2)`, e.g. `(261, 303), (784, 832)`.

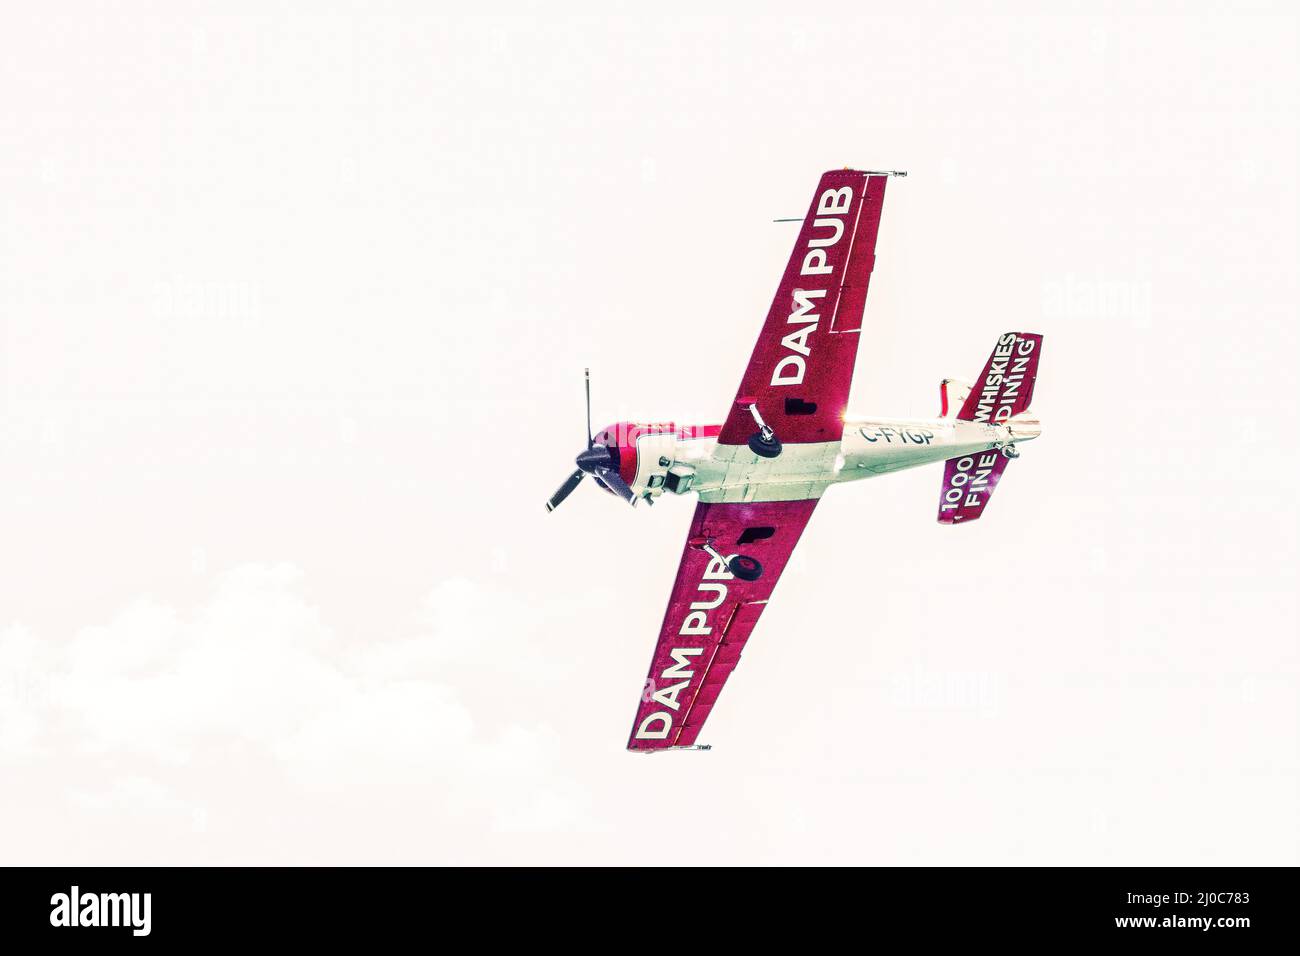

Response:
(0, 564), (598, 858)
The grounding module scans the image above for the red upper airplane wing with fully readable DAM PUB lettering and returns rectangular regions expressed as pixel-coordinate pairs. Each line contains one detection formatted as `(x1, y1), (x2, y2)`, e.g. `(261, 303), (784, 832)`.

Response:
(718, 169), (888, 445)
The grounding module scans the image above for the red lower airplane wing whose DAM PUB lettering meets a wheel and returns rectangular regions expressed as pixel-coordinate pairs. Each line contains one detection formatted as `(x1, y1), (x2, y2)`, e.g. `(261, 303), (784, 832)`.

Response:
(628, 498), (818, 752)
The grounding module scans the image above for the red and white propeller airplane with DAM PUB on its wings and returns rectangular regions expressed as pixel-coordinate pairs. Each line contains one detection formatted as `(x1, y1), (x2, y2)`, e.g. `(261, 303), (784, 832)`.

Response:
(546, 169), (1043, 753)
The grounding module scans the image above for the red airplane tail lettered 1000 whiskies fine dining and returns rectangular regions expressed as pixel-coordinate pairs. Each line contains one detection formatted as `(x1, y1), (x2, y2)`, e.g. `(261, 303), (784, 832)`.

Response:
(939, 332), (1043, 524)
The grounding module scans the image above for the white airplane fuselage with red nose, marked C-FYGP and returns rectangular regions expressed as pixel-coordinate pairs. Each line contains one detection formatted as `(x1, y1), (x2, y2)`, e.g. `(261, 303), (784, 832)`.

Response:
(597, 415), (1039, 502)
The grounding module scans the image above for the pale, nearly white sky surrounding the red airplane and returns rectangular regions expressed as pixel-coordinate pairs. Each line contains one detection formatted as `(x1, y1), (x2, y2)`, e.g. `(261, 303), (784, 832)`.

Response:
(0, 3), (1300, 865)
